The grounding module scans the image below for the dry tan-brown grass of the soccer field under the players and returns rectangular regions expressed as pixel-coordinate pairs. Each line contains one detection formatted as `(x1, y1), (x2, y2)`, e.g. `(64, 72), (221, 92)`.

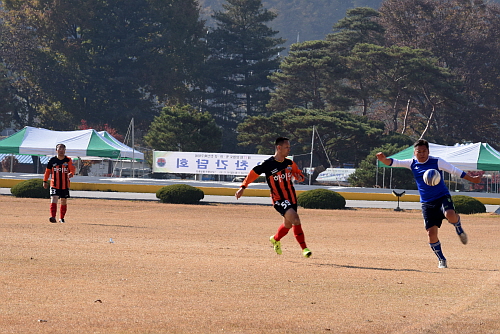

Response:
(0, 196), (500, 334)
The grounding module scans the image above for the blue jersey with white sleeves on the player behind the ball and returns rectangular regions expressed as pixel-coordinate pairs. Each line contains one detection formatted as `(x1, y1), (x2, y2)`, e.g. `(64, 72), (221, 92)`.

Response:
(390, 156), (466, 203)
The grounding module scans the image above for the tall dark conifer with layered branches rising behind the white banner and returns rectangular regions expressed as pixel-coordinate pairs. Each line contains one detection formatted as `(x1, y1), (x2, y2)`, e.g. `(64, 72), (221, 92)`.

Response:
(201, 0), (284, 151)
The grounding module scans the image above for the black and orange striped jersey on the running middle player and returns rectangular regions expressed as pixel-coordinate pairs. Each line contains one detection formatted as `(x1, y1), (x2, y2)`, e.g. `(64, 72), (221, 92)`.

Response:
(242, 156), (304, 204)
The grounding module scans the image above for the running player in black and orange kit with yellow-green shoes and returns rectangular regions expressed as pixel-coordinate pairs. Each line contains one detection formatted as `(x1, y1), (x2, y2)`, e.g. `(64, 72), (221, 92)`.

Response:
(235, 137), (312, 257)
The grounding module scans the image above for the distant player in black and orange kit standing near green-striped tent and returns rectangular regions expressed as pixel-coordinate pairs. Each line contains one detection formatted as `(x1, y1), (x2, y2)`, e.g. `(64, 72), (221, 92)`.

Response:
(43, 144), (75, 223)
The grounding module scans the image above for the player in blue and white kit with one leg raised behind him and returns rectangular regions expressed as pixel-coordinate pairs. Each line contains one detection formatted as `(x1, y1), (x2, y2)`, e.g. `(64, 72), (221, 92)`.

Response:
(377, 139), (481, 268)
